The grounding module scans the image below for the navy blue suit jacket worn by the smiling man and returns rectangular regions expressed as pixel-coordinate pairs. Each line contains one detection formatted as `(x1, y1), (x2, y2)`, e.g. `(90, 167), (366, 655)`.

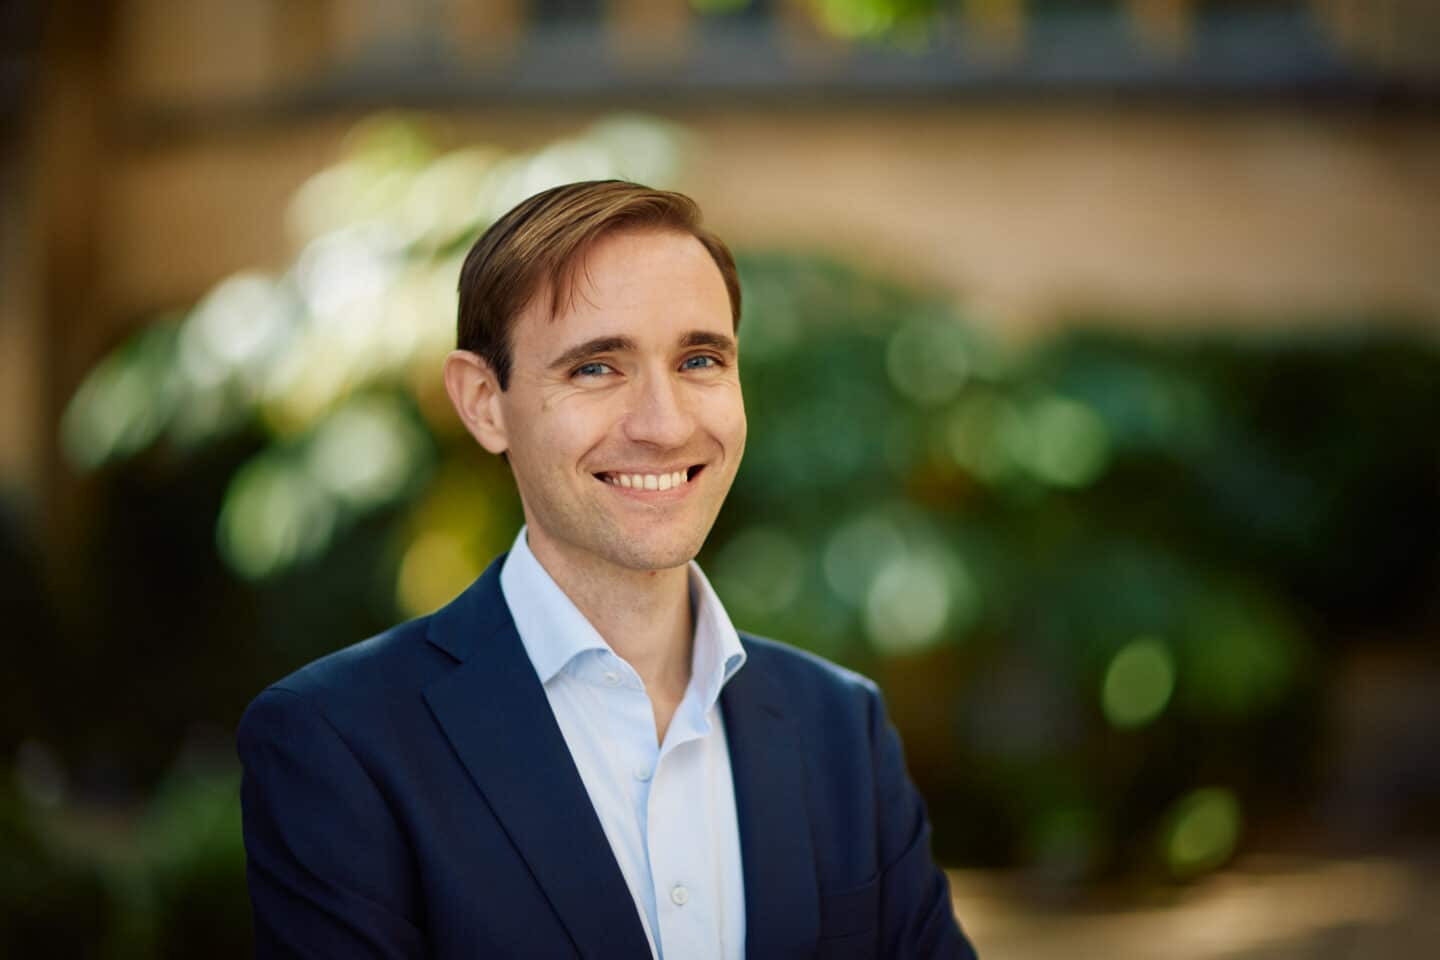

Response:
(239, 560), (973, 960)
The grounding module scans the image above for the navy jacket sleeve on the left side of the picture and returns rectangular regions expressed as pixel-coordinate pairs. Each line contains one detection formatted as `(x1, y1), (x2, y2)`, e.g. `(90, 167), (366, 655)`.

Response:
(239, 688), (426, 959)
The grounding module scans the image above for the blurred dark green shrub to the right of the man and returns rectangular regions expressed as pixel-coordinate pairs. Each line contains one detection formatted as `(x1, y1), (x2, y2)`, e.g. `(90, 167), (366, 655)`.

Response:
(725, 269), (1440, 881)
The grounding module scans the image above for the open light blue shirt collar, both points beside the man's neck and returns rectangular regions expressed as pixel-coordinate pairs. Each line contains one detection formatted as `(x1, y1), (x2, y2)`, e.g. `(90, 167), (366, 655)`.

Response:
(500, 527), (746, 708)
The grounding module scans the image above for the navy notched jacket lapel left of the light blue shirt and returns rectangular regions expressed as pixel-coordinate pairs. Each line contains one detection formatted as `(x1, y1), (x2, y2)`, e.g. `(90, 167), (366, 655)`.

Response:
(425, 557), (650, 957)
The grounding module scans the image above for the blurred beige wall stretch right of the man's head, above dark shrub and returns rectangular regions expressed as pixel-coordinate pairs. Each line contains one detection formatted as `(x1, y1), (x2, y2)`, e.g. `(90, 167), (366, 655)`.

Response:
(693, 107), (1440, 336)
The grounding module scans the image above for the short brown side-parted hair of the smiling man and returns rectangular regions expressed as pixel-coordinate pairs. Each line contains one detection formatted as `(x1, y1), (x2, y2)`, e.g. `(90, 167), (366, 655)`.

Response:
(456, 180), (740, 390)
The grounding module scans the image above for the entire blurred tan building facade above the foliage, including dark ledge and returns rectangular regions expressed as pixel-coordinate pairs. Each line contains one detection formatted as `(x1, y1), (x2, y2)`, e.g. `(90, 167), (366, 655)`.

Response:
(0, 0), (1440, 533)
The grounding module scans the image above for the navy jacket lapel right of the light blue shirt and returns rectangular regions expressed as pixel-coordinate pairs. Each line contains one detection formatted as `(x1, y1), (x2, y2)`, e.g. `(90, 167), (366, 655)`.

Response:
(720, 641), (819, 959)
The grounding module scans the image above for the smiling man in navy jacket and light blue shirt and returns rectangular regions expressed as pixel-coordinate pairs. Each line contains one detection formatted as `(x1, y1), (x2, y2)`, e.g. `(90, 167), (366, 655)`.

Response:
(239, 181), (973, 960)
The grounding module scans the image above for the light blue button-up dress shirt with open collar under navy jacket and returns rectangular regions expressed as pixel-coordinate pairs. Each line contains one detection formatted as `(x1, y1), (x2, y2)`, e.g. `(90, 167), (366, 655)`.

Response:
(500, 528), (744, 960)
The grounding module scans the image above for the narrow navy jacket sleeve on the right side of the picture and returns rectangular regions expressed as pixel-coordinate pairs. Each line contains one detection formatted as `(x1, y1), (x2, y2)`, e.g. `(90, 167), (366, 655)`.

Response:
(870, 692), (975, 960)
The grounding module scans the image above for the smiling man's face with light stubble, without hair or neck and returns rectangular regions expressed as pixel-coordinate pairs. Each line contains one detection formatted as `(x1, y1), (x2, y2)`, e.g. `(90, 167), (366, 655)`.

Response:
(497, 230), (746, 574)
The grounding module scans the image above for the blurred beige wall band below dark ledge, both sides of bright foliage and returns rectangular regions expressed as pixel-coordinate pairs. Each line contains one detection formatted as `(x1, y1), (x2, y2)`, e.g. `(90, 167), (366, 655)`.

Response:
(96, 107), (1440, 337)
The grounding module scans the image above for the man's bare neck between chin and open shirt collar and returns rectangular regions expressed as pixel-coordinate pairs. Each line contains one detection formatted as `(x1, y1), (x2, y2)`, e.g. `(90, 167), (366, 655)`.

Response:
(527, 537), (694, 701)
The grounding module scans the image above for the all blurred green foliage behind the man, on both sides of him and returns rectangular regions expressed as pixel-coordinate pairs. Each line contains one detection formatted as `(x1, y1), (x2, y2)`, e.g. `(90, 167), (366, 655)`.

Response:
(4, 118), (1440, 956)
